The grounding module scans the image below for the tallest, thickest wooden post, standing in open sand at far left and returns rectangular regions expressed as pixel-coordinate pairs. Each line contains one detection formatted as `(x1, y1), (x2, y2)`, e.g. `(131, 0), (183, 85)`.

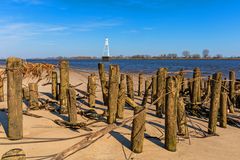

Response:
(7, 57), (23, 140)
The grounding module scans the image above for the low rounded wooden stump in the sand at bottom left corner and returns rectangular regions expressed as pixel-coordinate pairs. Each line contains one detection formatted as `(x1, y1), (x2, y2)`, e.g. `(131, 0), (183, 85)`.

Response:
(1, 148), (26, 160)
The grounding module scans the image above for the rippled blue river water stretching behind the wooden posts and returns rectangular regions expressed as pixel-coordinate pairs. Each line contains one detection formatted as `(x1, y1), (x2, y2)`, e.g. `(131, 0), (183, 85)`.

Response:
(0, 59), (240, 78)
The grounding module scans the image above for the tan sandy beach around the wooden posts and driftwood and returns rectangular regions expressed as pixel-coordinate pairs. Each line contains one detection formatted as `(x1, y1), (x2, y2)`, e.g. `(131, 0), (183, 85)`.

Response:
(0, 70), (240, 160)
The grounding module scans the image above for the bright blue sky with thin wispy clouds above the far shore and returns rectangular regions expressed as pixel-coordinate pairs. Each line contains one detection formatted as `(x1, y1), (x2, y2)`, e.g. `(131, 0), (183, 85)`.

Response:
(0, 0), (240, 58)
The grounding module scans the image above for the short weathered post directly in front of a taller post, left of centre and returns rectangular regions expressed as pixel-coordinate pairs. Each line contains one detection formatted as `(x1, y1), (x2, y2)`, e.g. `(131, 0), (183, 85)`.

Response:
(67, 88), (77, 124)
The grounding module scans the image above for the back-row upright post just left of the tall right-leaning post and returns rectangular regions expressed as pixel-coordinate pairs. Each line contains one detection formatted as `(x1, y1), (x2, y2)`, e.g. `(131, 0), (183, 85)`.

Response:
(191, 68), (201, 110)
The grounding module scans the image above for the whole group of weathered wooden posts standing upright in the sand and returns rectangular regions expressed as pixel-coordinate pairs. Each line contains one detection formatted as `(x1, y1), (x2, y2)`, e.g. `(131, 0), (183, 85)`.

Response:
(0, 58), (236, 153)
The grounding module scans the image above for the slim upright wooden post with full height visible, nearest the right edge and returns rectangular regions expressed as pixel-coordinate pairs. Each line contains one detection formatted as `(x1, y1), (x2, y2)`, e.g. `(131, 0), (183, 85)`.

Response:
(229, 70), (236, 107)
